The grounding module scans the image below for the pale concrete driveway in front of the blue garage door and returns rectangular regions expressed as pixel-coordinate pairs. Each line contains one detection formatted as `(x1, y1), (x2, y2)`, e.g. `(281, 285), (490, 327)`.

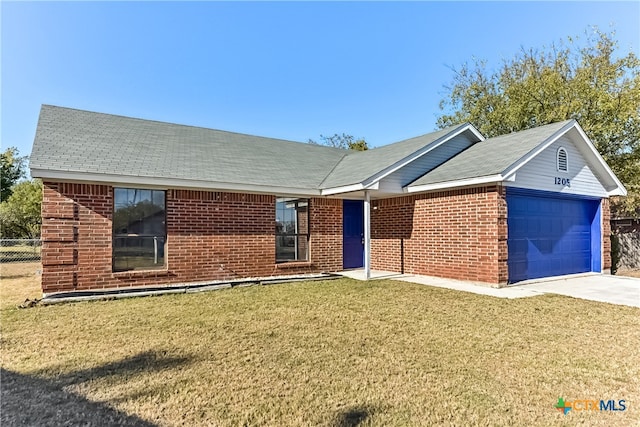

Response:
(509, 274), (640, 307)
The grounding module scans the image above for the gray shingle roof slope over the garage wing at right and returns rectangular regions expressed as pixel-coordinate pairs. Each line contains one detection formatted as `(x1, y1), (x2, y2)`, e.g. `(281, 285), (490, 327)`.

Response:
(409, 120), (572, 187)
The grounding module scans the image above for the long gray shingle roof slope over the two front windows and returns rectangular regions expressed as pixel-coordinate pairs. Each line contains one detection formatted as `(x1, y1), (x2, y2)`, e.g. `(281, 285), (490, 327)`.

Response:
(30, 105), (347, 189)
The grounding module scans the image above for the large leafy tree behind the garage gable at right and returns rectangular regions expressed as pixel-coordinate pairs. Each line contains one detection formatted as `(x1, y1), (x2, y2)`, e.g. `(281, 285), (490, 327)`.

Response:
(438, 28), (640, 214)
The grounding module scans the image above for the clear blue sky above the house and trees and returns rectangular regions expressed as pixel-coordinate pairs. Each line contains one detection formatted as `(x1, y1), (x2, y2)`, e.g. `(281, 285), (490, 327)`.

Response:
(0, 1), (640, 162)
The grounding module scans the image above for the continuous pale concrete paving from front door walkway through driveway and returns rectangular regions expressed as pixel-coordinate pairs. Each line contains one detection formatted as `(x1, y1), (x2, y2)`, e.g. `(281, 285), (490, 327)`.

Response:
(339, 269), (640, 307)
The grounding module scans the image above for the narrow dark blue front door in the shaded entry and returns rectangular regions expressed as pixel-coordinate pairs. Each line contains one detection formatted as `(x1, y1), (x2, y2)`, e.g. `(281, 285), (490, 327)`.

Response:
(342, 200), (364, 269)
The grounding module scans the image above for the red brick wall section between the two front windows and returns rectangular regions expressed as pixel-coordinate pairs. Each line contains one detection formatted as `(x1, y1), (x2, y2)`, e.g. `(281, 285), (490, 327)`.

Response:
(167, 190), (275, 281)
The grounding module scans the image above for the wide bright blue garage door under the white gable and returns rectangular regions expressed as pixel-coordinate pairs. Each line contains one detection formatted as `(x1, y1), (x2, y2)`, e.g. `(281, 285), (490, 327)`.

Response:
(507, 189), (601, 283)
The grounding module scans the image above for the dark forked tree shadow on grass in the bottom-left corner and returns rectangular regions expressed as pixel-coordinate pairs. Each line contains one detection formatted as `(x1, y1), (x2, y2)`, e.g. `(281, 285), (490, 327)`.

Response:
(0, 352), (189, 427)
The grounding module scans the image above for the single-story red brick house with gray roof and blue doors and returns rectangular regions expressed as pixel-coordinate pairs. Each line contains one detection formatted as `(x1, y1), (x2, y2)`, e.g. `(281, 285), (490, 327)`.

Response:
(30, 105), (626, 295)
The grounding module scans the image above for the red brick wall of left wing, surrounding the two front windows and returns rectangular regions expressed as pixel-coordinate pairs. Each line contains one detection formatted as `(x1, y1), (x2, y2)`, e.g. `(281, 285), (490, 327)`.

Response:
(42, 182), (342, 293)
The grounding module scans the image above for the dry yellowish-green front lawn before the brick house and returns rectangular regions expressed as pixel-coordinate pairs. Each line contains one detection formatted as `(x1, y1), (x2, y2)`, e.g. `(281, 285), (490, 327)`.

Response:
(0, 262), (640, 426)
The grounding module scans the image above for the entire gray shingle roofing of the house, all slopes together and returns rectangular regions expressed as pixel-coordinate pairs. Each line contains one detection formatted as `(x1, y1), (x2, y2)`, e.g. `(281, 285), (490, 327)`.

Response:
(30, 105), (580, 196)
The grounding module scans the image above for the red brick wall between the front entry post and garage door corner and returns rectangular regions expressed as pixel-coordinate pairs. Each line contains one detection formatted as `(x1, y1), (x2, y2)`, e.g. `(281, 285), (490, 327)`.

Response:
(371, 186), (507, 283)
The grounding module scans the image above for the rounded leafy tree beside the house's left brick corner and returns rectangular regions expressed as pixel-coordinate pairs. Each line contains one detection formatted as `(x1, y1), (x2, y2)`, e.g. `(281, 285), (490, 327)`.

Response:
(0, 179), (42, 239)
